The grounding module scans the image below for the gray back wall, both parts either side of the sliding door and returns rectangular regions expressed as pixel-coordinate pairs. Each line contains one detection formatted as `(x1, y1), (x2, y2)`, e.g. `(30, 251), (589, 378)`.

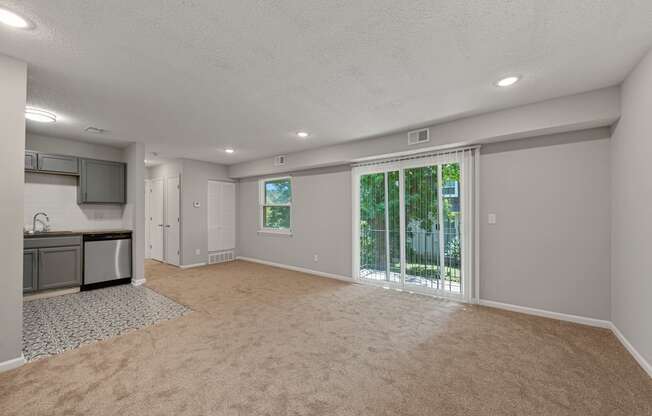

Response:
(237, 129), (610, 319)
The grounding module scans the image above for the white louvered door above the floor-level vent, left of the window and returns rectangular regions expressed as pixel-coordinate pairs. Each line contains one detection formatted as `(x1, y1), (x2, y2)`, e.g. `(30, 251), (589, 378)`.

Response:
(206, 181), (235, 252)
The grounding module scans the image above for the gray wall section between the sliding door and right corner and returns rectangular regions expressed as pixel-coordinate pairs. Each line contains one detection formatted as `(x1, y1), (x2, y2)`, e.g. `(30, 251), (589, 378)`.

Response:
(480, 136), (610, 320)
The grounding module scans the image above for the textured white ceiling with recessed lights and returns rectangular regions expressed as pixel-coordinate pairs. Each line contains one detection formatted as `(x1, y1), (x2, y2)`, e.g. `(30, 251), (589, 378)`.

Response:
(0, 0), (652, 163)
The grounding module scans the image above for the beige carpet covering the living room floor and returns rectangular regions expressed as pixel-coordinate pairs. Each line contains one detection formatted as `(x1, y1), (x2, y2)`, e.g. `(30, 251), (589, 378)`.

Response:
(0, 261), (652, 416)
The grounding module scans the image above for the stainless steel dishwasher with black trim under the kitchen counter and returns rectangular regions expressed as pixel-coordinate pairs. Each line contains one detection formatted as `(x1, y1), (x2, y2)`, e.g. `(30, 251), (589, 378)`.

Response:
(82, 232), (131, 290)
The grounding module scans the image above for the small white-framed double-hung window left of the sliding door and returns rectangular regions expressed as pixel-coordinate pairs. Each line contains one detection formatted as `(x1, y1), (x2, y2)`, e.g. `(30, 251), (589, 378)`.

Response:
(259, 176), (292, 234)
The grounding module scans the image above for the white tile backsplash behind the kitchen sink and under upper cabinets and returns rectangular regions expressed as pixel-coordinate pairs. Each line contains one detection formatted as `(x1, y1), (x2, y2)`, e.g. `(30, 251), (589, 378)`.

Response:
(23, 172), (124, 231)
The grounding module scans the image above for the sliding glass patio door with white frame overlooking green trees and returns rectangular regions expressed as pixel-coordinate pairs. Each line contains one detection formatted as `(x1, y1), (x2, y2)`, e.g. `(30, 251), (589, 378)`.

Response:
(354, 161), (464, 297)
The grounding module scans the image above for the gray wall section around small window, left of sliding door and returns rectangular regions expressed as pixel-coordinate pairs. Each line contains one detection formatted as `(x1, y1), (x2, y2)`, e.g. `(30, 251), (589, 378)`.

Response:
(237, 167), (352, 277)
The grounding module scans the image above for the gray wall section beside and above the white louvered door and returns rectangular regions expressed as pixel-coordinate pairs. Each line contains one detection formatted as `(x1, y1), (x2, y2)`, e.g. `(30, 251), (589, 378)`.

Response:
(179, 159), (230, 265)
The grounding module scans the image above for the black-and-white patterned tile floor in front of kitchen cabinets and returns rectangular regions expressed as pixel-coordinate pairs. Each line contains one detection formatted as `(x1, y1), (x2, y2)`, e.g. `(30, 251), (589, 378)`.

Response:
(23, 285), (190, 361)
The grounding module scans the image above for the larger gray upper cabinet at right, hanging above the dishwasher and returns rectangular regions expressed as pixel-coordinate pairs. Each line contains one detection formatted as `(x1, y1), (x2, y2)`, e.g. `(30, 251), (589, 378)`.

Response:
(77, 159), (127, 204)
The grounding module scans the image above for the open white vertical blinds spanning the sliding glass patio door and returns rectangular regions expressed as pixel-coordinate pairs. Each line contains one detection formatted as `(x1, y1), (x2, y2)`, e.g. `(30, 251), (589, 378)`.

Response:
(353, 147), (478, 300)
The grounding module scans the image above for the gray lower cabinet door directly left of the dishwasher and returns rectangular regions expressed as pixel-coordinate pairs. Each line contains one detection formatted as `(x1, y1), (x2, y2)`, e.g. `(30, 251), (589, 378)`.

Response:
(38, 246), (81, 290)
